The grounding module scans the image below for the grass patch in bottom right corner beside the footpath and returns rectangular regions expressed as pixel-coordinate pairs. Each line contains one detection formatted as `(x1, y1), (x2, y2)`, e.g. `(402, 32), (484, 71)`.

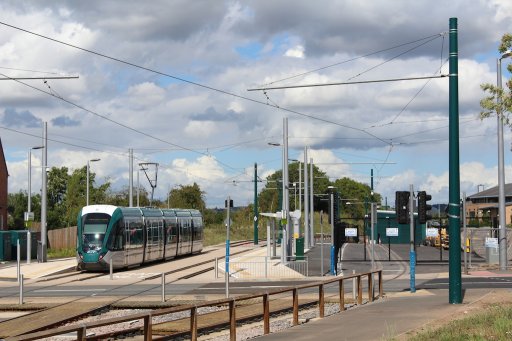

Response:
(410, 305), (512, 341)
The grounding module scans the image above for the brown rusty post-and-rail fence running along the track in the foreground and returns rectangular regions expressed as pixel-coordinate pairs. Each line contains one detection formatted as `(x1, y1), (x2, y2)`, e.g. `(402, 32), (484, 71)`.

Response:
(6, 270), (384, 341)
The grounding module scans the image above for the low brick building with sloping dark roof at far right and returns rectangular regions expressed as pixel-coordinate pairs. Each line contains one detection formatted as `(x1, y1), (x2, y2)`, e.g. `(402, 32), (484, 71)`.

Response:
(466, 183), (512, 227)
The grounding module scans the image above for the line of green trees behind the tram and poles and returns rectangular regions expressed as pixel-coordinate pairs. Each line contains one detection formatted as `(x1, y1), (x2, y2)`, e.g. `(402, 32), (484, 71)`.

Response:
(8, 162), (381, 230)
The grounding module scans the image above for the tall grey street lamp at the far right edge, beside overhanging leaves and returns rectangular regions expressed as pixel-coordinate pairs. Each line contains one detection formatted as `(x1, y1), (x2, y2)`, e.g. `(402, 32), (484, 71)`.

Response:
(496, 50), (512, 270)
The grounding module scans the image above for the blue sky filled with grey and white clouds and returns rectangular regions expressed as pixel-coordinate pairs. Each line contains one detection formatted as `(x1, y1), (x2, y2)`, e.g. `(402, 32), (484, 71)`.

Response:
(0, 0), (512, 207)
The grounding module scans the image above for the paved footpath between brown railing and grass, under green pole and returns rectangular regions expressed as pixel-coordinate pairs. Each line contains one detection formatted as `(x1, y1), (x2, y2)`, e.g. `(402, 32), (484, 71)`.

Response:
(260, 289), (500, 341)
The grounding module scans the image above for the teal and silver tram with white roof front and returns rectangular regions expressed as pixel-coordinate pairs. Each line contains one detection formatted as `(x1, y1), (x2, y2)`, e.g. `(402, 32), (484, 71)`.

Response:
(77, 205), (204, 271)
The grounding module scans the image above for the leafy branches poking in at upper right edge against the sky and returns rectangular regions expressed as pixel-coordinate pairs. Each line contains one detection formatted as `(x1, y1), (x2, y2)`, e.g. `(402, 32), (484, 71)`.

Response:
(480, 33), (512, 127)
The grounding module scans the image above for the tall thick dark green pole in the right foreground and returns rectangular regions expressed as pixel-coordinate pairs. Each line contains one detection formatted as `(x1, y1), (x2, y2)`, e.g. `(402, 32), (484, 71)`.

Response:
(448, 18), (462, 304)
